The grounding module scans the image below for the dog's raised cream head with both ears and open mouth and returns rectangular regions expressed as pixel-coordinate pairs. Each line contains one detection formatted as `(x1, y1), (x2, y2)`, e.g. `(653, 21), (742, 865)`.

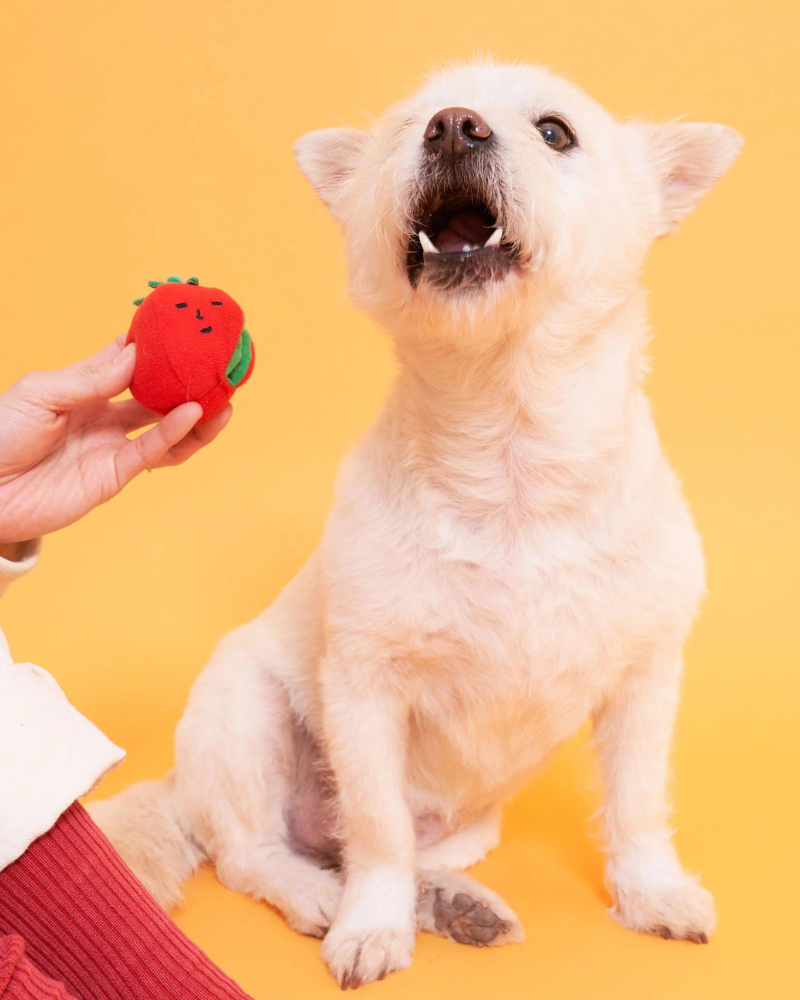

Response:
(295, 63), (742, 344)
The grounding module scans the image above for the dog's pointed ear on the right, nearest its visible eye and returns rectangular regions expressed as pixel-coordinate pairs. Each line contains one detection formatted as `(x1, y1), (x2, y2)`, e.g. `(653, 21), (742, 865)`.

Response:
(636, 122), (744, 236)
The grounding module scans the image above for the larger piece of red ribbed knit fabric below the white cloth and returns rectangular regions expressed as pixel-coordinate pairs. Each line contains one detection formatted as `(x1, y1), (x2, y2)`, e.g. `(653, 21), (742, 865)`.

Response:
(0, 802), (250, 1000)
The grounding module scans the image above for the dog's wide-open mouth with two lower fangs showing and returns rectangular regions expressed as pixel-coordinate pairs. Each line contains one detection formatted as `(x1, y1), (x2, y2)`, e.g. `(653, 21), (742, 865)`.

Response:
(406, 193), (517, 291)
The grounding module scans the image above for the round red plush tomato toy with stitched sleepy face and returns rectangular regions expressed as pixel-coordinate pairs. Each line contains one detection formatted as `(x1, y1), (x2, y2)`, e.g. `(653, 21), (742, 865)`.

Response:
(126, 275), (255, 421)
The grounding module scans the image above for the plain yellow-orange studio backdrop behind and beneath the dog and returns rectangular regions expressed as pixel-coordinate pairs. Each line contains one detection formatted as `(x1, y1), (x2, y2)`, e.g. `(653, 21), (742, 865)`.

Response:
(0, 0), (800, 1000)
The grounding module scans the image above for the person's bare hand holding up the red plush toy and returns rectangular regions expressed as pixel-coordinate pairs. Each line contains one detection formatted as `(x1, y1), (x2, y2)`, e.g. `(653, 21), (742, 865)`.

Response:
(0, 335), (233, 543)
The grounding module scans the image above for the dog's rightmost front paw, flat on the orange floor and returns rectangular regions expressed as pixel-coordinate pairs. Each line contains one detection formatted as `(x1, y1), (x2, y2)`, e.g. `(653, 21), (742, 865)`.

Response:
(611, 875), (717, 944)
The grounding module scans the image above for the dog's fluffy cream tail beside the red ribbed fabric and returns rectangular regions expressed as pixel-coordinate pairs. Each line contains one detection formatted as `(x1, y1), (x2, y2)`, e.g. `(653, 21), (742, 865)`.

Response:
(88, 775), (203, 910)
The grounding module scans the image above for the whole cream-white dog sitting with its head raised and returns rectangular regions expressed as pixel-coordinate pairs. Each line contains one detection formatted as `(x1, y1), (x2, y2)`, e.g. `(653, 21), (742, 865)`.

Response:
(94, 63), (741, 987)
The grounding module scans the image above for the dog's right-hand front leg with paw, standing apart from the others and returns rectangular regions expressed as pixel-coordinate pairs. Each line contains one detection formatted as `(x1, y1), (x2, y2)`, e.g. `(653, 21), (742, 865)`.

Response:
(595, 649), (716, 943)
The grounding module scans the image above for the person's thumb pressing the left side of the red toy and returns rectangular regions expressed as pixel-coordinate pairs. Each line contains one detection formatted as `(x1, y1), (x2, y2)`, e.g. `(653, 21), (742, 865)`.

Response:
(19, 344), (136, 411)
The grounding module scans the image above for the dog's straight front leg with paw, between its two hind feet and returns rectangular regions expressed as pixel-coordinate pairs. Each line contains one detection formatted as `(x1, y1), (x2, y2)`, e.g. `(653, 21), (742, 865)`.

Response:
(322, 653), (416, 989)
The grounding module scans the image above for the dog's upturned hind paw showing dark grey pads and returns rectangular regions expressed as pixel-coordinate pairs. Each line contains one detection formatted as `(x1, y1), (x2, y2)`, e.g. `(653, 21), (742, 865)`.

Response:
(417, 871), (525, 948)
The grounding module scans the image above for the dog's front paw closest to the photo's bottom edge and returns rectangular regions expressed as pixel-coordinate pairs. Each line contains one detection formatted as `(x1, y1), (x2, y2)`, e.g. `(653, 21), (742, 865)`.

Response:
(322, 925), (414, 990)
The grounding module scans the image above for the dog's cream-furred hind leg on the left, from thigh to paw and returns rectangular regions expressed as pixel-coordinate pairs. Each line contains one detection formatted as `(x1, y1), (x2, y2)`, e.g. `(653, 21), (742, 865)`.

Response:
(175, 564), (341, 936)
